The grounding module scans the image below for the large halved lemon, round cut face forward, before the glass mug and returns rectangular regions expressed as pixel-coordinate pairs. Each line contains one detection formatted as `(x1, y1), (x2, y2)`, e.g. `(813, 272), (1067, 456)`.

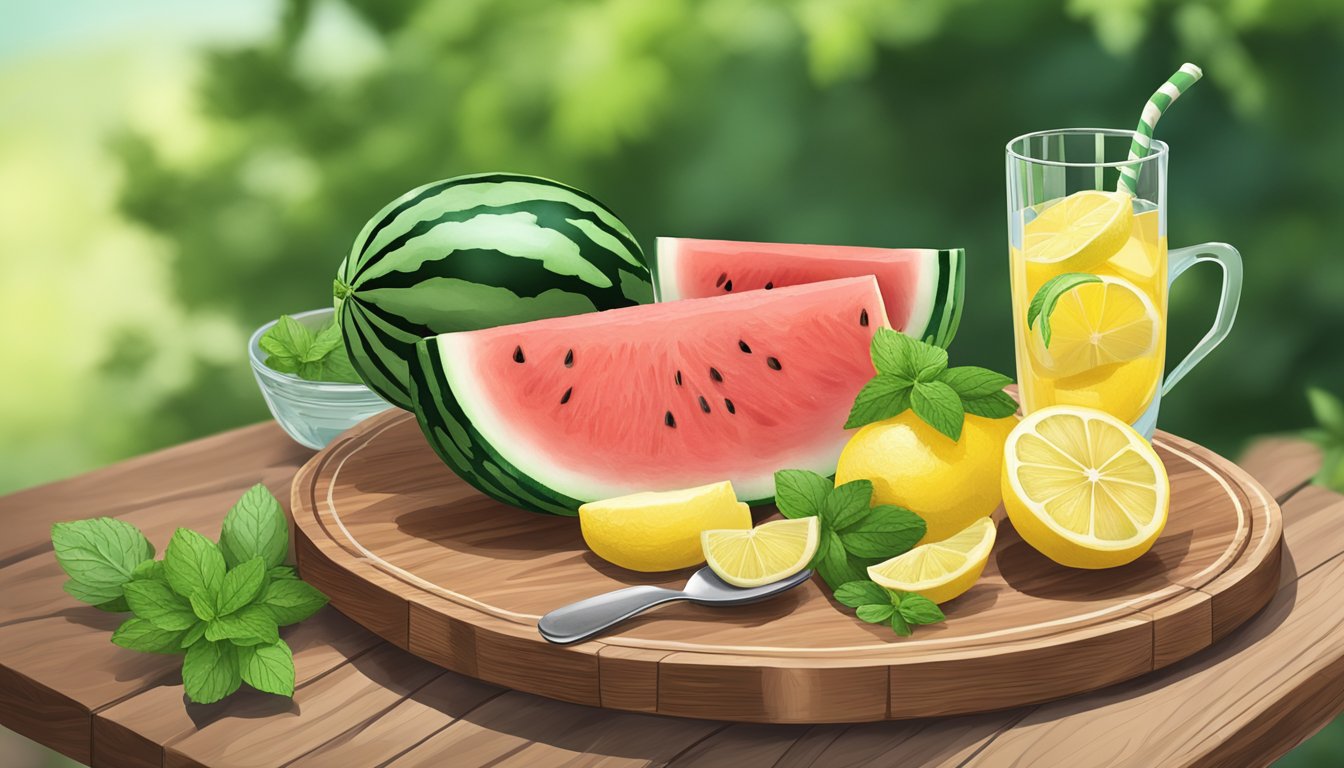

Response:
(1003, 405), (1171, 568)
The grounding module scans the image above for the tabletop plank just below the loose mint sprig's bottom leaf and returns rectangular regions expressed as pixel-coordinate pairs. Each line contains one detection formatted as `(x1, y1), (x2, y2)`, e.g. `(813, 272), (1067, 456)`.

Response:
(164, 643), (445, 768)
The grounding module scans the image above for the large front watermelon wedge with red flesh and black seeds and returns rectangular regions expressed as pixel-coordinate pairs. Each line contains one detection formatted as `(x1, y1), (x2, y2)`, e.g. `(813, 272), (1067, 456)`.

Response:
(410, 276), (887, 515)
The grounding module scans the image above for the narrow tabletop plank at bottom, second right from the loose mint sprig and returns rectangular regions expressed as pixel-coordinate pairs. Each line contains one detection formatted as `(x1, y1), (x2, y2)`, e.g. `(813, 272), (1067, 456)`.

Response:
(288, 673), (505, 768)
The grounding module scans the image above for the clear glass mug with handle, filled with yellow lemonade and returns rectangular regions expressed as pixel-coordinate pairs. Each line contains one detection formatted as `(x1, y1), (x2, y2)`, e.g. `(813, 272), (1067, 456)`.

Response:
(1007, 128), (1242, 437)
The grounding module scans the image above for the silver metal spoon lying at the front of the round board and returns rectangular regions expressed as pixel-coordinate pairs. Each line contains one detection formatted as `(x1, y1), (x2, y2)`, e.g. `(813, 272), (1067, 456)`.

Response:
(536, 566), (812, 646)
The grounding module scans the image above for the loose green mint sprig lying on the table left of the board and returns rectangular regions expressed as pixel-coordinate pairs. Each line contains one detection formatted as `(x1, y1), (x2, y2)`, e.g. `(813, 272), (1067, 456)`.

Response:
(51, 486), (327, 703)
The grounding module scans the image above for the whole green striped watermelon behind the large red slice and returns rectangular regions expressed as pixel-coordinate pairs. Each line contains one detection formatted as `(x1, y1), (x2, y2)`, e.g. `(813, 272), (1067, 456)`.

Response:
(333, 174), (653, 410)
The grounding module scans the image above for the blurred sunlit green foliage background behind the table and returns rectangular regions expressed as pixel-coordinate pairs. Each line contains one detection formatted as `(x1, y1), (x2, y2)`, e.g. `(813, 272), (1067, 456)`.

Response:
(0, 0), (1344, 765)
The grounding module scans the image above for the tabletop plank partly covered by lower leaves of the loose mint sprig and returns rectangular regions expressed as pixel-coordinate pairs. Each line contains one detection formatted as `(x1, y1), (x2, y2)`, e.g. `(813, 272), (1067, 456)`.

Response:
(93, 608), (383, 768)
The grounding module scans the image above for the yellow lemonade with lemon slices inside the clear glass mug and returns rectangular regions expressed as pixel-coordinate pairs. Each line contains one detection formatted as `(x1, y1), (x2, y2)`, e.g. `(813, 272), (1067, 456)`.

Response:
(1009, 191), (1167, 424)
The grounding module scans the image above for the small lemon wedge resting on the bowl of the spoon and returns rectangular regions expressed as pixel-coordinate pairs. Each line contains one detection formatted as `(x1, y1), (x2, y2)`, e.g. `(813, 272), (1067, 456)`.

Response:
(700, 516), (821, 586)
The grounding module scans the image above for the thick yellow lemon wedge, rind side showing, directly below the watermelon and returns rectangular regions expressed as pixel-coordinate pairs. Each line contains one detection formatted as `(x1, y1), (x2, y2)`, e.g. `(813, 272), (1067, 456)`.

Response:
(579, 482), (751, 572)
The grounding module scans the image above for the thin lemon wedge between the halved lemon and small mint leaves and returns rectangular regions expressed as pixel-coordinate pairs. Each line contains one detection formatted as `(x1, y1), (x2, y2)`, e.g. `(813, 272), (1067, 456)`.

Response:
(868, 518), (995, 603)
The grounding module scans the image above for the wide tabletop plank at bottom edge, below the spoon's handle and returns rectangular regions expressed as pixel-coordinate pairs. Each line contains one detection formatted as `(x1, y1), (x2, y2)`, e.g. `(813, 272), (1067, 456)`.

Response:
(386, 691), (723, 768)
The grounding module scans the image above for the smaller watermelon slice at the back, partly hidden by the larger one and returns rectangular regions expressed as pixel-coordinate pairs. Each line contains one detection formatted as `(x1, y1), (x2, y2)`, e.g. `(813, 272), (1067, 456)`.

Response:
(655, 237), (966, 347)
